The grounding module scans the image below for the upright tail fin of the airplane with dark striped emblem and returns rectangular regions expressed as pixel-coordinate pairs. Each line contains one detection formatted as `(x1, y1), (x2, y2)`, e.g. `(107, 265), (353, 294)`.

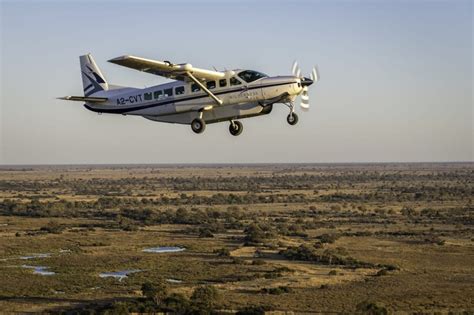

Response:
(79, 54), (109, 96)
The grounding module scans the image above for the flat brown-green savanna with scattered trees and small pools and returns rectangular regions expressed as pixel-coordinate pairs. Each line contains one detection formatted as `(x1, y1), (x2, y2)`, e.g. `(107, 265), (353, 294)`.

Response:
(0, 163), (474, 314)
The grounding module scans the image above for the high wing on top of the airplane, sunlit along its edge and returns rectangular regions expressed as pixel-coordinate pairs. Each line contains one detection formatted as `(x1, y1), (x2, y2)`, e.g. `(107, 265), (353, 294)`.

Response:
(109, 55), (225, 82)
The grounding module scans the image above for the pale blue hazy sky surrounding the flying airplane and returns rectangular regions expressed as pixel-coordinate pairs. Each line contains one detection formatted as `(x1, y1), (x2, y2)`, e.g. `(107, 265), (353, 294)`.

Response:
(0, 0), (474, 164)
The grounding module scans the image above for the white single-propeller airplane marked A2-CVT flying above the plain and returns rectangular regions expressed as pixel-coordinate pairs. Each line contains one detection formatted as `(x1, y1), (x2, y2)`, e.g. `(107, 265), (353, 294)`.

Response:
(59, 54), (319, 136)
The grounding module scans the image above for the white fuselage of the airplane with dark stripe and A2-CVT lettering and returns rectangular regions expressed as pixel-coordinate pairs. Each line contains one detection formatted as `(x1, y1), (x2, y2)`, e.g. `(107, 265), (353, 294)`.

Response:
(85, 74), (302, 124)
